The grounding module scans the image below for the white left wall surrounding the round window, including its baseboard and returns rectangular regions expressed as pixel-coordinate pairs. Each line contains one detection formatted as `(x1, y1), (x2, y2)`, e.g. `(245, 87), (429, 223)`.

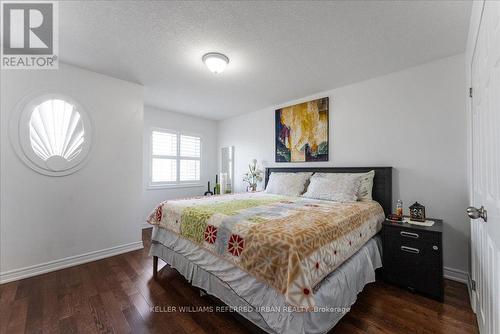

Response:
(0, 64), (143, 281)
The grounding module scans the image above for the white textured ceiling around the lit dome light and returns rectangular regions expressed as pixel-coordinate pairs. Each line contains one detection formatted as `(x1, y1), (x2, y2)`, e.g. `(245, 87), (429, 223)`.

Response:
(59, 1), (471, 119)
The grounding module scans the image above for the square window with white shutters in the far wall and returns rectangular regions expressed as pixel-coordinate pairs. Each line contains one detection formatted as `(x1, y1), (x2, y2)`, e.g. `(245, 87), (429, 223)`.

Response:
(150, 129), (201, 186)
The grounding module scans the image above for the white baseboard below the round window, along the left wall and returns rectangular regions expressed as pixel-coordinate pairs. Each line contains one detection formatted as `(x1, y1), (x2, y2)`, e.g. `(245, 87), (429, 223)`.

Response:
(0, 241), (144, 284)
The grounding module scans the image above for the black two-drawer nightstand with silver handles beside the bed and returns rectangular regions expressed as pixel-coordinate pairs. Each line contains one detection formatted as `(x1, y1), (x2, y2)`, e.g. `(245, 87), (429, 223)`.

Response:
(382, 218), (443, 302)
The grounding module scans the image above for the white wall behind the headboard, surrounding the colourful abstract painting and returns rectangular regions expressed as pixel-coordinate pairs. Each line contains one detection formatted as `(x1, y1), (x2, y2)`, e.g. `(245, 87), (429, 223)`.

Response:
(218, 55), (469, 278)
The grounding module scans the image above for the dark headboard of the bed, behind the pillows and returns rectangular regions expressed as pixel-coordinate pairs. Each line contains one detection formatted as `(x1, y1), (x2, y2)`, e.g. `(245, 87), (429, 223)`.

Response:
(265, 167), (392, 215)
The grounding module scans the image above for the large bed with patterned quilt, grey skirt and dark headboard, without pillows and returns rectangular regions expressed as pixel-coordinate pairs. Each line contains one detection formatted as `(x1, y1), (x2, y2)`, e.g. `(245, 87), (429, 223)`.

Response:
(148, 167), (392, 333)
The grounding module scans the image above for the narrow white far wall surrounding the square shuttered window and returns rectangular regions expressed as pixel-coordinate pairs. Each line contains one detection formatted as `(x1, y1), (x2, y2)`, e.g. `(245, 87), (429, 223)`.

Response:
(142, 106), (218, 223)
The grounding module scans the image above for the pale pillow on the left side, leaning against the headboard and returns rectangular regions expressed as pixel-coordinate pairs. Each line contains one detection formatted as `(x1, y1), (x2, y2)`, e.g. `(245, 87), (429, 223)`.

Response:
(264, 172), (312, 196)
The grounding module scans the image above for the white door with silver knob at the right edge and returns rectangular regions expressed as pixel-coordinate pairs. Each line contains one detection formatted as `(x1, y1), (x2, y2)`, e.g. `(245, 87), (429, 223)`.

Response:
(469, 0), (500, 334)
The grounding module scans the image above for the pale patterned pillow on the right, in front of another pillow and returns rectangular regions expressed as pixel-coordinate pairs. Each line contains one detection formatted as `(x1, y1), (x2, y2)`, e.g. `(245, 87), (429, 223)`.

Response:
(303, 173), (360, 202)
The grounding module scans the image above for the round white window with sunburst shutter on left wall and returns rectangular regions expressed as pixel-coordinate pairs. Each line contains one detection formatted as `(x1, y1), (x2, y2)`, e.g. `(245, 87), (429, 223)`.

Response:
(13, 94), (92, 176)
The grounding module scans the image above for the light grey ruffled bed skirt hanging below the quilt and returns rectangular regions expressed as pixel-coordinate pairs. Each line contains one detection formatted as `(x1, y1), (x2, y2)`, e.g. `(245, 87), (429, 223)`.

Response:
(150, 227), (382, 334)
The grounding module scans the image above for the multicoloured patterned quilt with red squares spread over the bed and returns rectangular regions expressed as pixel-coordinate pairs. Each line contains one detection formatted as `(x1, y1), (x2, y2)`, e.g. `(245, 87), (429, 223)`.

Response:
(148, 193), (384, 311)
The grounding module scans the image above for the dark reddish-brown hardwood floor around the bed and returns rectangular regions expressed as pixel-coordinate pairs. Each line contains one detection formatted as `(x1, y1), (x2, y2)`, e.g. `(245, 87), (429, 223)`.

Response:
(0, 230), (478, 334)
